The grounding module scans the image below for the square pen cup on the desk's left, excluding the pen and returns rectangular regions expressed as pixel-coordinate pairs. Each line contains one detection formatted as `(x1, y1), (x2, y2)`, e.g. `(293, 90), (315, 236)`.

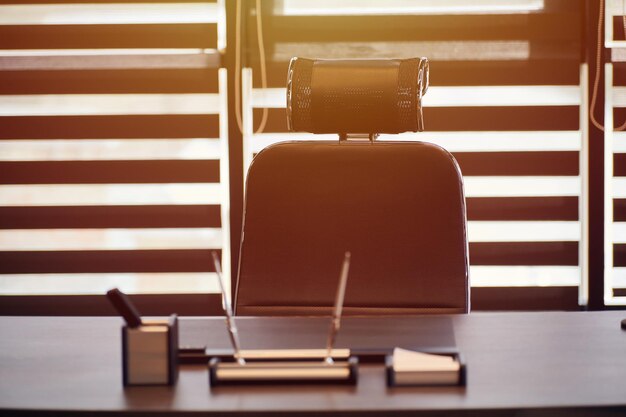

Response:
(122, 314), (178, 386)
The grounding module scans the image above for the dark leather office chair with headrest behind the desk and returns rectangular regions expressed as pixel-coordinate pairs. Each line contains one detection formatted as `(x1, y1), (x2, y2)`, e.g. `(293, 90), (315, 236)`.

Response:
(235, 58), (469, 315)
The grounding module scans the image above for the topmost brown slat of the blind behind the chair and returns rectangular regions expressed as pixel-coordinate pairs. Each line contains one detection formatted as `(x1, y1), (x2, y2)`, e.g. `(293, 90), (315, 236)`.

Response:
(260, 13), (582, 40)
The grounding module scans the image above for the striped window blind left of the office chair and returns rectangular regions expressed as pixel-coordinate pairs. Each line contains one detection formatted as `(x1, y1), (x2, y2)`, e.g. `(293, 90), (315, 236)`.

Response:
(0, 1), (230, 295)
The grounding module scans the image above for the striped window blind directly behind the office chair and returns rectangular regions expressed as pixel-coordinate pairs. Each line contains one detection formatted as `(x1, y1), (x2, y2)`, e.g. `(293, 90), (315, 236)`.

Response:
(242, 0), (588, 309)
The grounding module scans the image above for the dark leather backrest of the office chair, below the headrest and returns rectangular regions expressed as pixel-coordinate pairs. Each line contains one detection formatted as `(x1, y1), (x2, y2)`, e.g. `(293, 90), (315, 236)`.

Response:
(235, 141), (469, 315)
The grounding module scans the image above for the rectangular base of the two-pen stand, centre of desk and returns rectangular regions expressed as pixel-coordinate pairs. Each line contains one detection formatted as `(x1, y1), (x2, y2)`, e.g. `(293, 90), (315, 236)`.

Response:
(209, 356), (358, 387)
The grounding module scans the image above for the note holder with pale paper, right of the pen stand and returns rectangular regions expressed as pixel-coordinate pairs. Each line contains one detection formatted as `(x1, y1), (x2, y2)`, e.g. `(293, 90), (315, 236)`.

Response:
(390, 348), (461, 385)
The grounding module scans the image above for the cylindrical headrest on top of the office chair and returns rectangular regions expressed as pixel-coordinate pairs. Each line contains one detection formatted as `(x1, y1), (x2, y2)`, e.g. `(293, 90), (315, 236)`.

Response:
(287, 57), (428, 134)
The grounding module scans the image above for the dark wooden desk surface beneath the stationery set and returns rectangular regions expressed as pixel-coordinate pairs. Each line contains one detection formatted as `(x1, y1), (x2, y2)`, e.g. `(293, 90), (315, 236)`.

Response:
(0, 311), (626, 416)
